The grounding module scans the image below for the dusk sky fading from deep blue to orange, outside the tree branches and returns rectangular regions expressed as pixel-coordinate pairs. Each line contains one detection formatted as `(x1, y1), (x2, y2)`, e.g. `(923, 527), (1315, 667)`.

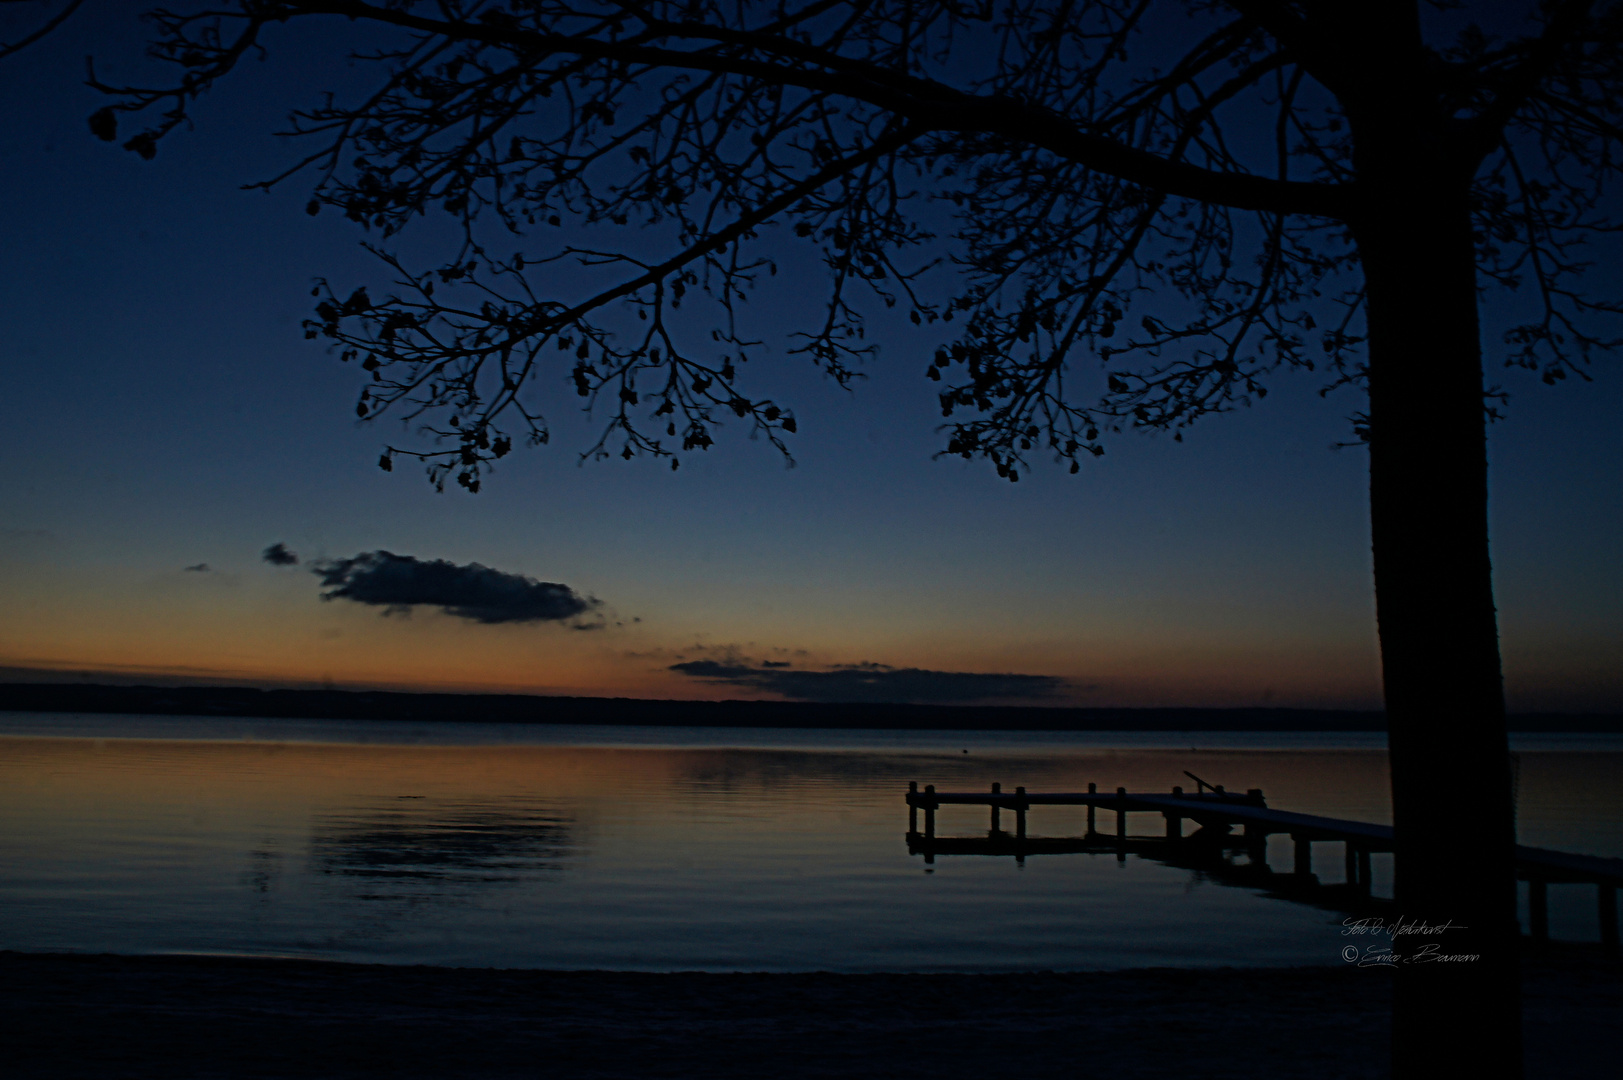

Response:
(0, 14), (1623, 711)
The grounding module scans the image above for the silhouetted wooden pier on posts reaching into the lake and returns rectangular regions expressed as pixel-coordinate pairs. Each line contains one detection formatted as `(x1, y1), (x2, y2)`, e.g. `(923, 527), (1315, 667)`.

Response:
(907, 780), (1623, 955)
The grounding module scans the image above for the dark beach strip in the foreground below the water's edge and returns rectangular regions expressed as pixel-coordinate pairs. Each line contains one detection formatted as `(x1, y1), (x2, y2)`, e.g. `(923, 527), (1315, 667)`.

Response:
(0, 953), (1623, 1080)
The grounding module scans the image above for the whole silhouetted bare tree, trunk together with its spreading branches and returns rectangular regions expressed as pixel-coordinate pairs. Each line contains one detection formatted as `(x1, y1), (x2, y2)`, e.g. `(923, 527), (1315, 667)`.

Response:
(91, 0), (1623, 1075)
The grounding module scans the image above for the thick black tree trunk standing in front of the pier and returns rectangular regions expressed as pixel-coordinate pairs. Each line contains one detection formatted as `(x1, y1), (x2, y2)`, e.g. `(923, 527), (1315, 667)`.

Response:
(1355, 178), (1521, 1078)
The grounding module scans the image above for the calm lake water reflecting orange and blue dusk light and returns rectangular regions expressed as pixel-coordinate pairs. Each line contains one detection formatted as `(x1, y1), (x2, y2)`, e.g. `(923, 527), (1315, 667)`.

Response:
(0, 713), (1623, 971)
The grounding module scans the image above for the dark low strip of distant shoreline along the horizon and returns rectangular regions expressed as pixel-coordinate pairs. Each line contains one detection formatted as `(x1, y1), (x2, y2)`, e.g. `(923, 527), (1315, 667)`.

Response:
(0, 682), (1623, 734)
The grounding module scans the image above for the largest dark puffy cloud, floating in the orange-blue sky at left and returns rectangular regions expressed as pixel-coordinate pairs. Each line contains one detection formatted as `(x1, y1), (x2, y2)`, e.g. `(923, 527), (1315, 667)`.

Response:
(312, 551), (602, 630)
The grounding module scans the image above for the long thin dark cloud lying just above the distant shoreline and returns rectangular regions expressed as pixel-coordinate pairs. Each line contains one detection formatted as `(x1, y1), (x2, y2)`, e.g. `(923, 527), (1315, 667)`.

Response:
(670, 659), (1065, 705)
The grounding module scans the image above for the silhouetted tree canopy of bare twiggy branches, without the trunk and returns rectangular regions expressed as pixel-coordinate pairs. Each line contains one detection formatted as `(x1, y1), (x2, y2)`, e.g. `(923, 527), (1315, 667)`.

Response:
(91, 0), (1623, 489)
